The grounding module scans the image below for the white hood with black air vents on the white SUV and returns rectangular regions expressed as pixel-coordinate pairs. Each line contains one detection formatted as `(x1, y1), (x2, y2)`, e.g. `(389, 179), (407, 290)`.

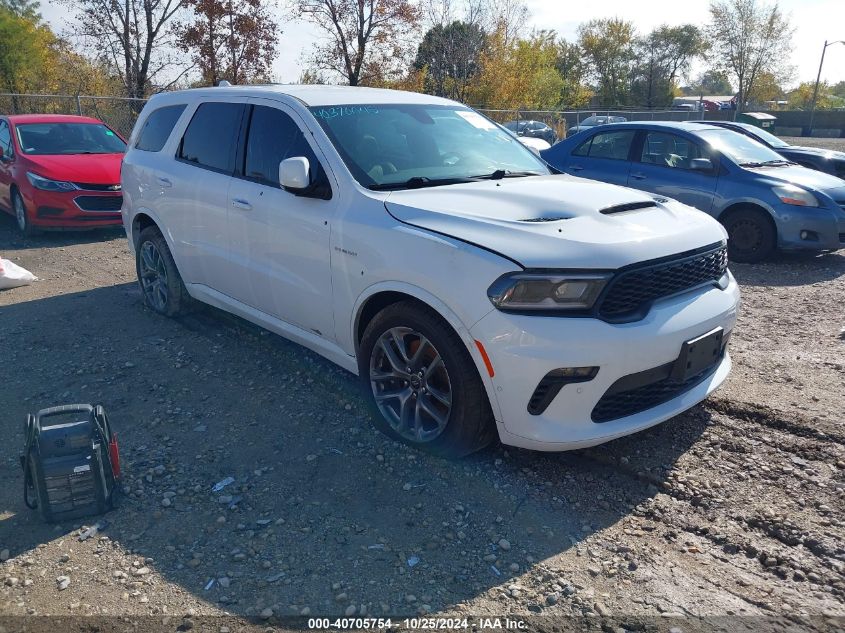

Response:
(385, 175), (726, 269)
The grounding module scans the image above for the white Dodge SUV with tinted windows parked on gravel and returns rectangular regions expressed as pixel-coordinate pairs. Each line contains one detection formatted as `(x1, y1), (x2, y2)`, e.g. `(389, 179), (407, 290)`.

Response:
(122, 86), (739, 457)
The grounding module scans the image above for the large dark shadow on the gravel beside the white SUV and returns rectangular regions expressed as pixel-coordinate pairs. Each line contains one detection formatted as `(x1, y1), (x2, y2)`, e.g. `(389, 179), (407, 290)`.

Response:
(0, 282), (720, 614)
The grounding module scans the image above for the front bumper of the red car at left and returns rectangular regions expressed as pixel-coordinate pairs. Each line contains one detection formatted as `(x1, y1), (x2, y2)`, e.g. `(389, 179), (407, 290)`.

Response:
(21, 187), (123, 228)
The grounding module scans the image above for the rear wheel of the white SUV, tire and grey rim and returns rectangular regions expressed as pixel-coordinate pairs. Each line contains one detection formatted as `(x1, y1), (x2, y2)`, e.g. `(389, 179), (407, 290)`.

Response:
(135, 226), (193, 317)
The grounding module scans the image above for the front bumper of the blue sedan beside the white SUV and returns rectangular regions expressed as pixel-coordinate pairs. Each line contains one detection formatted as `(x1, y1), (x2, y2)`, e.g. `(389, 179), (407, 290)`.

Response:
(775, 204), (845, 250)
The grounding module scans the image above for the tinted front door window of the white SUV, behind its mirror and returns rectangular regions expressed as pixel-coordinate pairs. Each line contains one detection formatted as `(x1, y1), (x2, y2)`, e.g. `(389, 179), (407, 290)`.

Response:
(244, 106), (319, 187)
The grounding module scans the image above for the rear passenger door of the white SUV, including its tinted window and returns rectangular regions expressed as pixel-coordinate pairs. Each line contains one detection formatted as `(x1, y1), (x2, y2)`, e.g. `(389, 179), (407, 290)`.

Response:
(154, 98), (246, 297)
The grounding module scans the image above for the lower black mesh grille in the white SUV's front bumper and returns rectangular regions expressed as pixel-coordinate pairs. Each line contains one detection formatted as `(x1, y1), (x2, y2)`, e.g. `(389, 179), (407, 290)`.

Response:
(591, 358), (724, 422)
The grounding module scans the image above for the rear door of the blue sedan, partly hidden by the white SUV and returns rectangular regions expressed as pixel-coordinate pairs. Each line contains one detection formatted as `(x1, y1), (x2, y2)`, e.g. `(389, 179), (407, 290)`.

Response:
(564, 128), (636, 185)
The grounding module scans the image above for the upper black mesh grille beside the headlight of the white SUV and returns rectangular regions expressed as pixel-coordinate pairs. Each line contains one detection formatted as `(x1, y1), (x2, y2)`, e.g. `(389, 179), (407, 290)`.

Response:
(598, 245), (728, 321)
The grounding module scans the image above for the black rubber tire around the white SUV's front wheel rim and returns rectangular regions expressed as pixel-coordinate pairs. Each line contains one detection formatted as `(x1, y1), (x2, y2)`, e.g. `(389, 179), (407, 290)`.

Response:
(358, 301), (496, 459)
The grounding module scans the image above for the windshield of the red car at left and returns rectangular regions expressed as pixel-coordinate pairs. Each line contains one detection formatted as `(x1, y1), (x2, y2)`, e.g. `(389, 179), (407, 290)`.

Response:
(16, 123), (126, 155)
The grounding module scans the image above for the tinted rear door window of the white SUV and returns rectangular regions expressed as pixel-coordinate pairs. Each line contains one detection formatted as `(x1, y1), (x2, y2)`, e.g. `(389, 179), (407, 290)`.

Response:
(177, 101), (244, 173)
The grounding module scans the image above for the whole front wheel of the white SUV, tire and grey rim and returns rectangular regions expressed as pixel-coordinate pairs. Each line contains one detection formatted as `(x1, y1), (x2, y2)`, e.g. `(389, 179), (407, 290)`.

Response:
(358, 301), (495, 458)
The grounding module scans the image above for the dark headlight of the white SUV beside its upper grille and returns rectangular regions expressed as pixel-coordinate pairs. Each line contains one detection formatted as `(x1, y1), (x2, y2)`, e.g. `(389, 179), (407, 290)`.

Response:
(487, 272), (611, 311)
